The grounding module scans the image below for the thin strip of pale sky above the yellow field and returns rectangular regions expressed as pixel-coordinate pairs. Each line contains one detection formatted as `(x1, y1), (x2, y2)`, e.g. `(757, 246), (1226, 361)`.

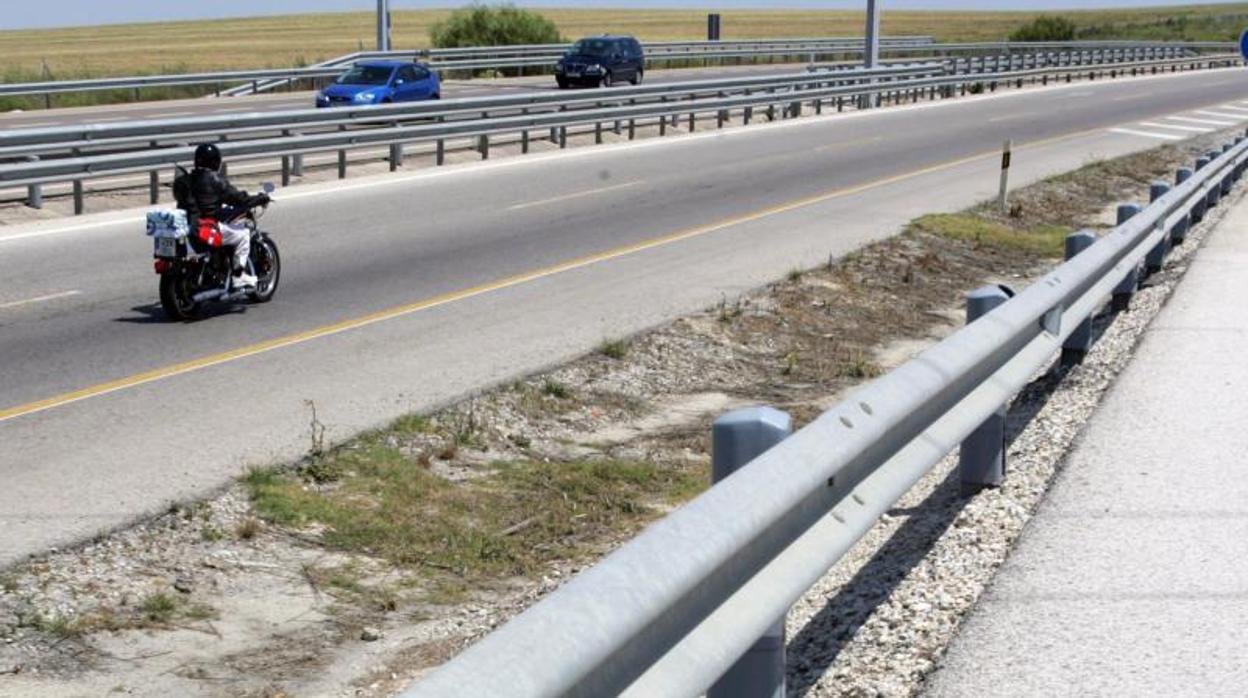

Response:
(0, 0), (1243, 30)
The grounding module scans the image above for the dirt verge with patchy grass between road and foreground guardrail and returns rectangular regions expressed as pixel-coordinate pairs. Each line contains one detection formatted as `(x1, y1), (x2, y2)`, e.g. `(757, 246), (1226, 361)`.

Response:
(0, 129), (1221, 697)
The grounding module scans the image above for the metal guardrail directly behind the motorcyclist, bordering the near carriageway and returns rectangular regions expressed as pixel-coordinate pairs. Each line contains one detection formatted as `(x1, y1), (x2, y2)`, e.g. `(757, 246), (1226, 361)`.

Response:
(0, 57), (1242, 212)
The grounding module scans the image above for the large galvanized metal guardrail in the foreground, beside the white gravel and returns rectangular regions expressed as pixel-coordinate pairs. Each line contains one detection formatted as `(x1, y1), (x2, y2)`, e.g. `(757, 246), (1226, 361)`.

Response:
(403, 131), (1248, 698)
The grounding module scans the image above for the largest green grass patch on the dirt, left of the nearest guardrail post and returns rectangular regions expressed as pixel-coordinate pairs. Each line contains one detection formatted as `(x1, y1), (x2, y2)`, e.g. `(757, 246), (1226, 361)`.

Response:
(246, 437), (706, 594)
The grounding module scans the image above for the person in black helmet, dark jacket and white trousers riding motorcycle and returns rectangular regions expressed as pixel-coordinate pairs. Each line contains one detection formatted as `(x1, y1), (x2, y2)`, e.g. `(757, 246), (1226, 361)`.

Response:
(173, 144), (270, 290)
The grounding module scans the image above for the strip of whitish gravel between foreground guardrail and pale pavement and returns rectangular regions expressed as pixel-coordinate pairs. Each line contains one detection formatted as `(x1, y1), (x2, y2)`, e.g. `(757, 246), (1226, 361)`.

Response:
(786, 183), (1241, 697)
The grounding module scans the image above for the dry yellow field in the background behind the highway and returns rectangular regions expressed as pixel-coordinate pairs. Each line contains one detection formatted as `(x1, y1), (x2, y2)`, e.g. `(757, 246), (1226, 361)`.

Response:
(0, 4), (1248, 79)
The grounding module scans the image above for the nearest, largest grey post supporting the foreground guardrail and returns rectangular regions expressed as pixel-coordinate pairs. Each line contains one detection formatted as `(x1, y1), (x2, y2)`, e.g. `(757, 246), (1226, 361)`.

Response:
(706, 407), (792, 698)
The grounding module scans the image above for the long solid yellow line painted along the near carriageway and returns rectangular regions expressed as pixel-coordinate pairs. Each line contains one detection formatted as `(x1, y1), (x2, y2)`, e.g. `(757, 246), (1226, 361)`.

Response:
(0, 129), (1101, 422)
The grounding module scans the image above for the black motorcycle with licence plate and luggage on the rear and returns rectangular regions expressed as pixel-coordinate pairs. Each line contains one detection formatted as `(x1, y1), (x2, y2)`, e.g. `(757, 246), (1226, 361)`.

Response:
(147, 184), (282, 320)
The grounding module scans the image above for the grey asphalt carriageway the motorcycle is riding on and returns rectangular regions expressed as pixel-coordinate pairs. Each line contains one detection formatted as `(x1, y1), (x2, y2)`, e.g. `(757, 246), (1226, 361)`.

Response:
(0, 70), (1248, 564)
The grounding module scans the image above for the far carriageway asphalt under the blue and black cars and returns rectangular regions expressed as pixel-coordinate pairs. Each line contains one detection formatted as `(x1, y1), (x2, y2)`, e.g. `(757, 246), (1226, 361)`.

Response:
(0, 64), (838, 129)
